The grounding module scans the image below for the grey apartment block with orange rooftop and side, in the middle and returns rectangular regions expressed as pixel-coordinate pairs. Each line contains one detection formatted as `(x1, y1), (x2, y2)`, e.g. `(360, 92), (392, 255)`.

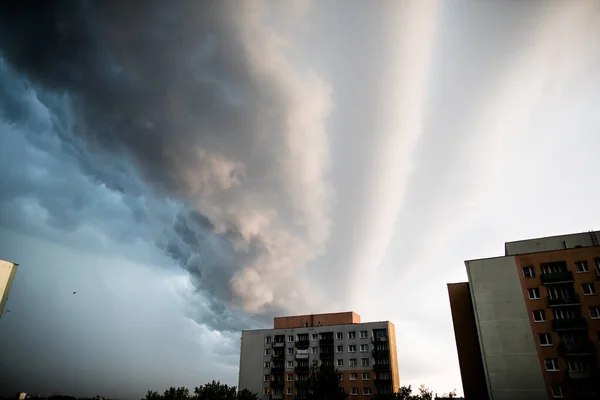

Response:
(238, 312), (400, 400)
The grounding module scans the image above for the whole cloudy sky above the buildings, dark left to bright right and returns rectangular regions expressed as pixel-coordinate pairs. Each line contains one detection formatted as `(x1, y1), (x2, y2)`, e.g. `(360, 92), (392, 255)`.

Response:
(0, 1), (600, 398)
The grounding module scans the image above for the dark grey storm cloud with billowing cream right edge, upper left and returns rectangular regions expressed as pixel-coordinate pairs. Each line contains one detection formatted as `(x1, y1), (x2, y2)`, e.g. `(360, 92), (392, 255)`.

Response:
(0, 1), (330, 316)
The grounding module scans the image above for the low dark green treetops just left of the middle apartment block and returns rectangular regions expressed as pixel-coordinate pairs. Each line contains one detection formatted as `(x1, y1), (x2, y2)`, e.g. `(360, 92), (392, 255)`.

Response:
(142, 381), (258, 400)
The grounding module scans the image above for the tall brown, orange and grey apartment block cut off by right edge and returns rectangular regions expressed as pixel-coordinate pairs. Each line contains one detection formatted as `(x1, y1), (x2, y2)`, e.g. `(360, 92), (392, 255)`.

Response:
(448, 231), (600, 400)
